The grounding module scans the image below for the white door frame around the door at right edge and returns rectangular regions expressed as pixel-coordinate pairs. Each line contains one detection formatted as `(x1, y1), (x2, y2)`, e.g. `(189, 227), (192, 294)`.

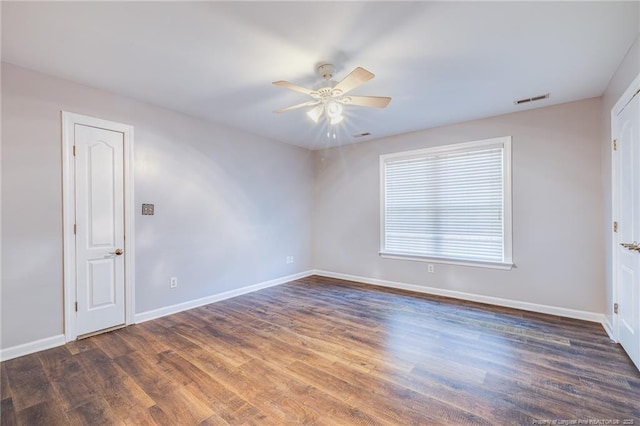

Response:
(607, 74), (640, 343)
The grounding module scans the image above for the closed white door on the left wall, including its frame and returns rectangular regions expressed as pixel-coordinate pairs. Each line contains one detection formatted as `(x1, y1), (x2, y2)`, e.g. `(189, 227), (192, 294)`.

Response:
(63, 112), (133, 341)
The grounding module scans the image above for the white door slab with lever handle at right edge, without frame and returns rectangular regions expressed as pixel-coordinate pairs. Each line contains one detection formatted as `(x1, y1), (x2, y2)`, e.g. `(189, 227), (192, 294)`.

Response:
(616, 90), (640, 368)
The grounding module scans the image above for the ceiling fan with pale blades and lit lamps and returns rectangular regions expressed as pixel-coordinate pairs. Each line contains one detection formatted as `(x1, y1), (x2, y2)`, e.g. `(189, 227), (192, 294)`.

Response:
(273, 64), (391, 124)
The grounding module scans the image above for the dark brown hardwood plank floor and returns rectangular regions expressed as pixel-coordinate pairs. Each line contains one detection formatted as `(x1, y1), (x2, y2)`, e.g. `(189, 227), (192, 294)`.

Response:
(0, 277), (640, 425)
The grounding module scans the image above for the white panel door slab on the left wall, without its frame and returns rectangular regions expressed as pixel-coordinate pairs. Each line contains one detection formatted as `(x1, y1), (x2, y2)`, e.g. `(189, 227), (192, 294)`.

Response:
(74, 123), (125, 335)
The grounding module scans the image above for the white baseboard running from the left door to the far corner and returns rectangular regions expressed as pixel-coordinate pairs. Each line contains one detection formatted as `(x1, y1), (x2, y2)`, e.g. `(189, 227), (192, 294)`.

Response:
(135, 271), (313, 323)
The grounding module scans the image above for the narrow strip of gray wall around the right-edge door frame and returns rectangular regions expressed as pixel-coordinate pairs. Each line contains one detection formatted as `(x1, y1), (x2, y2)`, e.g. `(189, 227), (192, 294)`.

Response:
(601, 38), (640, 325)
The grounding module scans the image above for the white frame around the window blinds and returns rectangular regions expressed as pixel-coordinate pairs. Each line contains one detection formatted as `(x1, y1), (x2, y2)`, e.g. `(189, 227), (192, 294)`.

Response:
(379, 136), (514, 270)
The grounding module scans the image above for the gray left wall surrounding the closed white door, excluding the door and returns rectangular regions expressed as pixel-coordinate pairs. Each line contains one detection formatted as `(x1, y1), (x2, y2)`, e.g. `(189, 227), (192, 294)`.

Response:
(0, 64), (313, 348)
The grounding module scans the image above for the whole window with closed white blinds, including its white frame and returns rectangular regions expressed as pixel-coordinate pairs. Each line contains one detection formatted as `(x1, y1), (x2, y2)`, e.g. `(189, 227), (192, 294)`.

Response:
(380, 136), (512, 269)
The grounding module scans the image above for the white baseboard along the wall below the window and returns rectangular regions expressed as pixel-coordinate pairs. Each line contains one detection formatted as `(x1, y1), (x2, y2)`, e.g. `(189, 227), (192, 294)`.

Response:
(313, 270), (606, 324)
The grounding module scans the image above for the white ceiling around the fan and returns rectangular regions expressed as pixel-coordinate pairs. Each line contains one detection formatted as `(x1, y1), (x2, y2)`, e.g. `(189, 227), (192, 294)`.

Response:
(1, 1), (639, 149)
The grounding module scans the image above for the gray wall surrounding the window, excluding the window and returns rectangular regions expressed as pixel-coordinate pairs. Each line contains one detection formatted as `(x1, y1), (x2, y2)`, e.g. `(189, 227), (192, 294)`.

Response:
(313, 98), (605, 313)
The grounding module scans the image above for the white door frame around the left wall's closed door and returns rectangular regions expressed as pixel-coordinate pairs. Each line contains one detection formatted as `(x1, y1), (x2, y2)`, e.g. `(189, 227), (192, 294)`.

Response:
(61, 111), (135, 342)
